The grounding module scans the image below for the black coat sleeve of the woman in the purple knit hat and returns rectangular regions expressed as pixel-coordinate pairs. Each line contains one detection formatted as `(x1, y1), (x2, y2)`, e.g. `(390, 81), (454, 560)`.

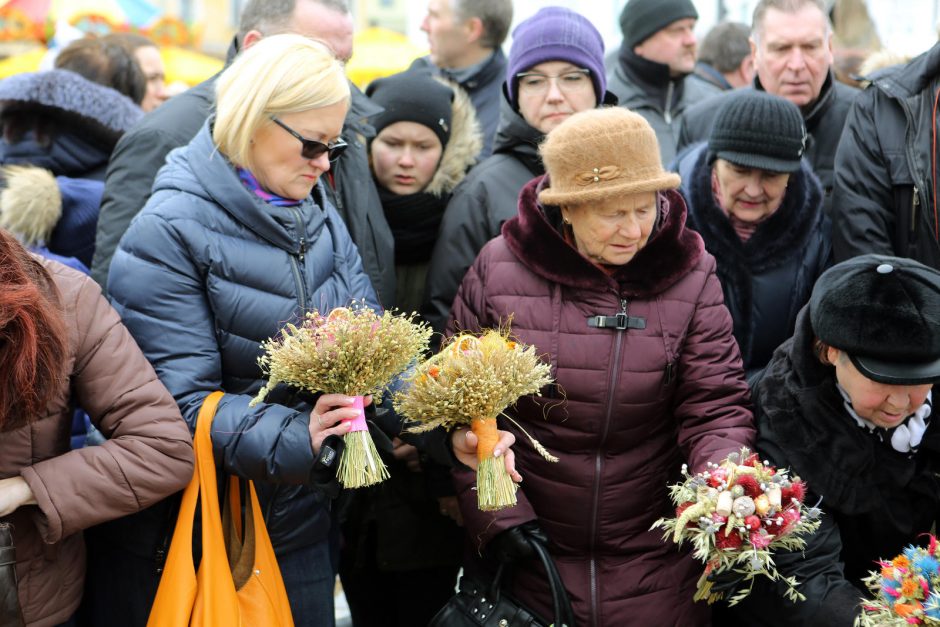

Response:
(422, 178), (499, 333)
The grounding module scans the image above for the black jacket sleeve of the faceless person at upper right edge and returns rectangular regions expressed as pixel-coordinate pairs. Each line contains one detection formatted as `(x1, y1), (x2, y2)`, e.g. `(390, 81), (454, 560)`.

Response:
(832, 88), (903, 263)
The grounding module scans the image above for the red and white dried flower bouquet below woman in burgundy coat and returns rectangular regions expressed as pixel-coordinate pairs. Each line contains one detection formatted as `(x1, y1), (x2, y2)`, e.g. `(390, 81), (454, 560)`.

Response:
(651, 448), (821, 605)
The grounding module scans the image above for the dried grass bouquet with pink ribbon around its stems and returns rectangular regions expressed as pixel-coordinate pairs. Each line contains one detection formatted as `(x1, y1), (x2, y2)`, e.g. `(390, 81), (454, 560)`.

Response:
(251, 306), (431, 488)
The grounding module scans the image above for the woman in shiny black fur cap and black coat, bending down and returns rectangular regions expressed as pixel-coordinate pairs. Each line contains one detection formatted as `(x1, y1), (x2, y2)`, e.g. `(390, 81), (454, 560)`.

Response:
(715, 255), (940, 627)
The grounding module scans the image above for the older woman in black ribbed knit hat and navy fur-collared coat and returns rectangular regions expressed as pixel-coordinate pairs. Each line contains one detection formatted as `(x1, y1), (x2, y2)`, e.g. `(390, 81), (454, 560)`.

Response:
(674, 91), (832, 380)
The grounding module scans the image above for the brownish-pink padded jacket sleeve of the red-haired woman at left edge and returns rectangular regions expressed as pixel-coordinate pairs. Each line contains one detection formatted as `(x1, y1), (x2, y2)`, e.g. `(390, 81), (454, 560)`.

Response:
(22, 273), (193, 543)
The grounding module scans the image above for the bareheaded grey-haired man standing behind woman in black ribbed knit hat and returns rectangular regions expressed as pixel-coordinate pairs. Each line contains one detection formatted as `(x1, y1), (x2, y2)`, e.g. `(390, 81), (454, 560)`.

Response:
(678, 0), (858, 215)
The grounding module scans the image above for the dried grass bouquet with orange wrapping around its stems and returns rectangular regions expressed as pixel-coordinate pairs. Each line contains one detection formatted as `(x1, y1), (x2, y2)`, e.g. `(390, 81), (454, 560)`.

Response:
(393, 329), (558, 511)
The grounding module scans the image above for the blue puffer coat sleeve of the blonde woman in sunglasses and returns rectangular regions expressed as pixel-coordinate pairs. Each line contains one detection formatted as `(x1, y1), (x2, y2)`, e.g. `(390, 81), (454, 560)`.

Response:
(109, 211), (322, 484)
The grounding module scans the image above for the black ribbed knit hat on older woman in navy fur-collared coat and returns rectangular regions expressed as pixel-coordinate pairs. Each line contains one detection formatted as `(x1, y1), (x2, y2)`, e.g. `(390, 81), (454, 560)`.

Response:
(708, 89), (806, 172)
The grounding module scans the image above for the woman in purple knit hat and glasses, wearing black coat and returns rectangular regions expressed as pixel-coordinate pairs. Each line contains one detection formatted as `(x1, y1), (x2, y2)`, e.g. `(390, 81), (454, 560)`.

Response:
(421, 7), (616, 332)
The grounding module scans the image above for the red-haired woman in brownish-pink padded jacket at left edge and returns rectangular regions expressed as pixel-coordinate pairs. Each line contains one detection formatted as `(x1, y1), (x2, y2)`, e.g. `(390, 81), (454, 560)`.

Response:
(0, 230), (193, 625)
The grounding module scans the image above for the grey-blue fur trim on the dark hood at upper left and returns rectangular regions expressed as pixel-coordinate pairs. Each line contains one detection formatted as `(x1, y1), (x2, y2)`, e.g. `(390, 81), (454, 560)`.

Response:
(0, 70), (144, 152)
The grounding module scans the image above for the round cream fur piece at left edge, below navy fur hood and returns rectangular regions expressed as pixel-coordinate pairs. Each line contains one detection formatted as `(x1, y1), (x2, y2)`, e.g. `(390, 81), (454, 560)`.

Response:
(0, 165), (62, 246)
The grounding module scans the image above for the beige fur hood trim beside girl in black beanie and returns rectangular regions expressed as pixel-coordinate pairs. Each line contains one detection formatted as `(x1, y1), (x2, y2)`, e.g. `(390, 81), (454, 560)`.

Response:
(424, 76), (483, 196)
